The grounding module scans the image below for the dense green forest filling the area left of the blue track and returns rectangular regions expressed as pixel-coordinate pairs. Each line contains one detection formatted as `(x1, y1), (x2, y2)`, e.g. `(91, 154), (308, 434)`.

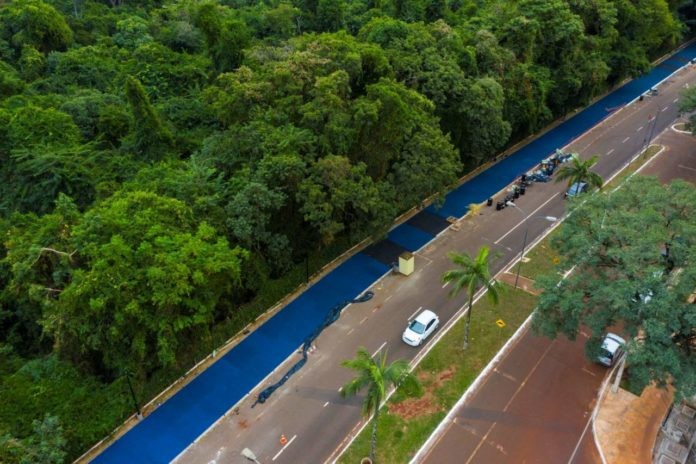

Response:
(0, 0), (694, 463)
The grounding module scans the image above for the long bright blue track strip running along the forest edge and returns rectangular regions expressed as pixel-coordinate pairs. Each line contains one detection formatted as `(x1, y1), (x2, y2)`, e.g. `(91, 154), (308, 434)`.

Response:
(93, 44), (696, 464)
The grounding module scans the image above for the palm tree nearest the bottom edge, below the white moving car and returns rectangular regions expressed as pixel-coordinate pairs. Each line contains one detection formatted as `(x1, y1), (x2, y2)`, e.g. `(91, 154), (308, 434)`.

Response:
(341, 347), (420, 462)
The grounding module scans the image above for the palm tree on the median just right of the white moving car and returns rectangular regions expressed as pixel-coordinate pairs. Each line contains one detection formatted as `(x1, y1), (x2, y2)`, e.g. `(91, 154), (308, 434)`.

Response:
(442, 246), (501, 349)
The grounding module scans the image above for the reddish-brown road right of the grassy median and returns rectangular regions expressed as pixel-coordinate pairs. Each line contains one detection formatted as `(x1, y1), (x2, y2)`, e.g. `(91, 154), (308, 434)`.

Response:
(419, 106), (696, 464)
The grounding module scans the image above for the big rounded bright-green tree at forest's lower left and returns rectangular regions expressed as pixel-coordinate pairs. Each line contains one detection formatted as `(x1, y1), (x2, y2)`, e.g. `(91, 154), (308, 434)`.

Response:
(43, 192), (247, 374)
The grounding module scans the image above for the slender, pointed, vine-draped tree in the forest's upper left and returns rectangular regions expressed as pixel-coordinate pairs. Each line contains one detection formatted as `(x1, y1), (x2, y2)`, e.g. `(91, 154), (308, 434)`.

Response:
(121, 76), (174, 161)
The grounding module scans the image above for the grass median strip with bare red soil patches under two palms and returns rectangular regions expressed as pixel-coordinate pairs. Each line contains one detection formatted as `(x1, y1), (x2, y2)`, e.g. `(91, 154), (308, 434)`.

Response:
(339, 286), (536, 464)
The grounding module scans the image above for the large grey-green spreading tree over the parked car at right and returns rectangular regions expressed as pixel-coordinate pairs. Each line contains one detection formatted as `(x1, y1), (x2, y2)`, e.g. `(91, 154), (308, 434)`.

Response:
(533, 177), (696, 397)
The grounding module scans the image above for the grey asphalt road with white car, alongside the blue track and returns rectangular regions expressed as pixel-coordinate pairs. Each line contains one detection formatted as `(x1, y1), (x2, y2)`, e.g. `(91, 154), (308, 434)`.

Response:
(176, 62), (696, 463)
